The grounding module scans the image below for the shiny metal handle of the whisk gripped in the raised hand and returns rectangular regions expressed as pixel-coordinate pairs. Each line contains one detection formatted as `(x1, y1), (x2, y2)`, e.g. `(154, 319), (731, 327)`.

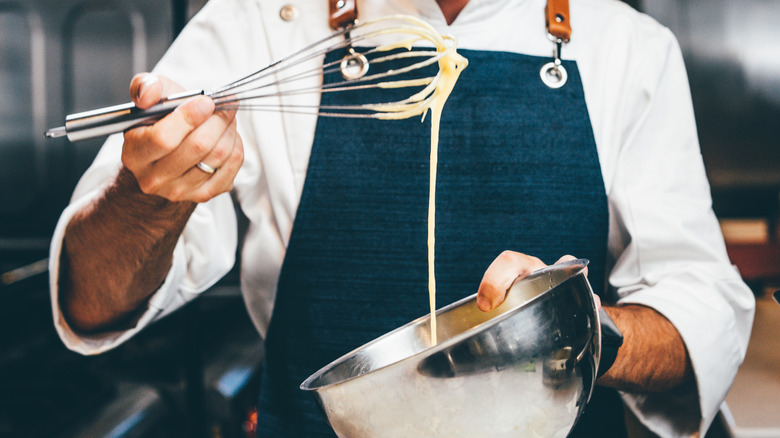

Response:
(46, 90), (205, 142)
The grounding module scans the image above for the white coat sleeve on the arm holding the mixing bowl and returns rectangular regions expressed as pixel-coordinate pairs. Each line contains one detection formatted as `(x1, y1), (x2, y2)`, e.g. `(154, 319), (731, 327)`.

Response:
(609, 27), (755, 436)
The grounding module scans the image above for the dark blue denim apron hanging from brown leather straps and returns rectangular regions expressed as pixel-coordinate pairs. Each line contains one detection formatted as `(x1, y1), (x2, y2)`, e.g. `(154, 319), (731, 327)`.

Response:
(258, 50), (624, 438)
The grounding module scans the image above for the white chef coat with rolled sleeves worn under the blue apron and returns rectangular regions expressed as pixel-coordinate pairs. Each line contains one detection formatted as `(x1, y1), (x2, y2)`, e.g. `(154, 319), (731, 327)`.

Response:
(50, 0), (754, 436)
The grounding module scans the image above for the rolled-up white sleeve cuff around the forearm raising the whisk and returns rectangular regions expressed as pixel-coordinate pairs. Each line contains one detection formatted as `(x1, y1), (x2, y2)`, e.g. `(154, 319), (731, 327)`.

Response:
(49, 135), (237, 354)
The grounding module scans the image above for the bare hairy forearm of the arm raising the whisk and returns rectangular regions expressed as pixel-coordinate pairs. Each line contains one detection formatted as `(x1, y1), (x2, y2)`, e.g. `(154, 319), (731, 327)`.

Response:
(59, 168), (196, 332)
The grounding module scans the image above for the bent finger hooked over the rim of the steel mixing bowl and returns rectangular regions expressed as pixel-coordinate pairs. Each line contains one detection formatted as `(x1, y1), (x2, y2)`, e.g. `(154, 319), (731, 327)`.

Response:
(477, 251), (547, 312)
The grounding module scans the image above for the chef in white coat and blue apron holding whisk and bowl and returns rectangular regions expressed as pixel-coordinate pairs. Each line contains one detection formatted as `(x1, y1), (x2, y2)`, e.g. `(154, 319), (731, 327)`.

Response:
(50, 0), (754, 437)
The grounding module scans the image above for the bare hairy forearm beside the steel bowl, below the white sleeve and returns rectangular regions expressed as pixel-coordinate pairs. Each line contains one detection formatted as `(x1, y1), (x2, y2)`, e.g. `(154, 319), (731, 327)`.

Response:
(598, 305), (693, 392)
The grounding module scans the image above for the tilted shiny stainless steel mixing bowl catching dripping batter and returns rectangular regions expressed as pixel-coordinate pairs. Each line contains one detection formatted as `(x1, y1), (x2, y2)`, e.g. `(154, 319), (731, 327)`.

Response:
(301, 260), (601, 438)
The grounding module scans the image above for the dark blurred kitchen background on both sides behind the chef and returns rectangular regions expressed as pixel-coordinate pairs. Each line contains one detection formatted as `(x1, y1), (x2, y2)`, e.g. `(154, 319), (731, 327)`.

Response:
(0, 0), (780, 438)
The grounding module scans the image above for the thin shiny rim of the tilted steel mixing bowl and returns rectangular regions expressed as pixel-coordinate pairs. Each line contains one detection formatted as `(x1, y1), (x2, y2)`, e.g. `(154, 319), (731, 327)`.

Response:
(299, 258), (589, 392)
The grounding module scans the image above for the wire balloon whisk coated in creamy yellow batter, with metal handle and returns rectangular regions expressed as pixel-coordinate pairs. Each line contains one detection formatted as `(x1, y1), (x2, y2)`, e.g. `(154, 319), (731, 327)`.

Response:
(45, 15), (466, 142)
